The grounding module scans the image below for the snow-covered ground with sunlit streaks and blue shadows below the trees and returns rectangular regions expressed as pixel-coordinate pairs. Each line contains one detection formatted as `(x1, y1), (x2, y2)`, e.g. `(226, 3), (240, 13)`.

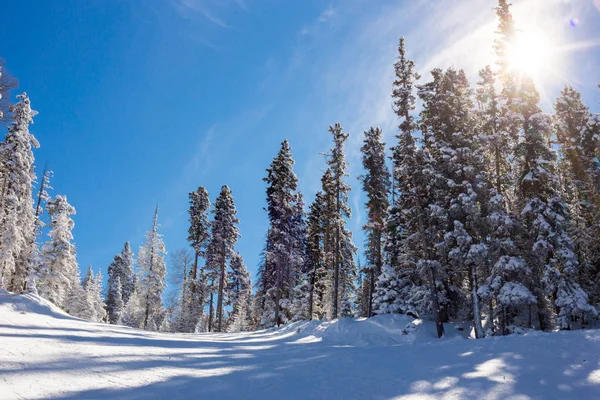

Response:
(0, 292), (600, 399)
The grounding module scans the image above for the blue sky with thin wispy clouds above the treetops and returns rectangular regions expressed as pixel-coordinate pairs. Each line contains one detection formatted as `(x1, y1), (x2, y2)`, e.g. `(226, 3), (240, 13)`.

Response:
(0, 0), (600, 288)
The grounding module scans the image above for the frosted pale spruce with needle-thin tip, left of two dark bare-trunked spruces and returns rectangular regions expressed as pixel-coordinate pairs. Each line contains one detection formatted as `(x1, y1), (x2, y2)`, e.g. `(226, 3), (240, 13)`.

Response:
(136, 206), (167, 331)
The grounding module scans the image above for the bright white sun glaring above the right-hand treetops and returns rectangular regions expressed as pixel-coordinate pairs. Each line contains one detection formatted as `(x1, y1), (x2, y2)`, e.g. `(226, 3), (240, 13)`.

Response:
(508, 31), (552, 77)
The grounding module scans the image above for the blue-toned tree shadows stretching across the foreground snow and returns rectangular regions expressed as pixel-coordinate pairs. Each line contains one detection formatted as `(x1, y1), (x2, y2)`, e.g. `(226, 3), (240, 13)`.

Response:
(0, 326), (600, 399)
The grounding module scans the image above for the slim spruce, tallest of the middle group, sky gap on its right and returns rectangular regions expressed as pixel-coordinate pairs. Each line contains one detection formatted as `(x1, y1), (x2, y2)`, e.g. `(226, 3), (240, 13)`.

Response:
(323, 123), (356, 319)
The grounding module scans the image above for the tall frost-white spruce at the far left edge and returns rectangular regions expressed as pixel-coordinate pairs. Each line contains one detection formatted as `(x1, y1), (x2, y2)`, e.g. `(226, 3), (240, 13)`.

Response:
(0, 93), (39, 293)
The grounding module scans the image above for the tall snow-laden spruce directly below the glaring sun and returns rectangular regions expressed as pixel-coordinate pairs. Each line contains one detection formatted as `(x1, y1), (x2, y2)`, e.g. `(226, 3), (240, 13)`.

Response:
(476, 66), (533, 334)
